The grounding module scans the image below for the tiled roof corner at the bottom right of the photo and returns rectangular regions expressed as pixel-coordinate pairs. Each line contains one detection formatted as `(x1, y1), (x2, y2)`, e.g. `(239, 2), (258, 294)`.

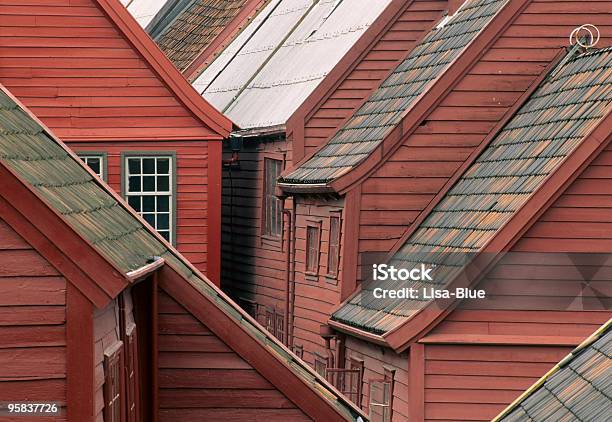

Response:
(494, 319), (612, 422)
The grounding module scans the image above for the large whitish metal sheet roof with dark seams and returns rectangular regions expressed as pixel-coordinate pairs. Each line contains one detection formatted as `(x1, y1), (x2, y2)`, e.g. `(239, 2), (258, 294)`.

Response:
(194, 0), (390, 129)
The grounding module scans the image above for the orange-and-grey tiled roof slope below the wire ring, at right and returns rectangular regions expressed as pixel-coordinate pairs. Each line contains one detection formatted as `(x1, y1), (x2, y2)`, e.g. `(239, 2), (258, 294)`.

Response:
(332, 48), (612, 334)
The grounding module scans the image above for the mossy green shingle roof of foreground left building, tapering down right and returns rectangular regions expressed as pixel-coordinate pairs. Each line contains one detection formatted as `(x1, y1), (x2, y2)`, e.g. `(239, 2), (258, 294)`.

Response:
(0, 85), (366, 421)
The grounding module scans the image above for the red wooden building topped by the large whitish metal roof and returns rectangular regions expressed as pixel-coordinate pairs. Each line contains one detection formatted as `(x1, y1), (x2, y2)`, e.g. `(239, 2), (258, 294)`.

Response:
(186, 0), (454, 352)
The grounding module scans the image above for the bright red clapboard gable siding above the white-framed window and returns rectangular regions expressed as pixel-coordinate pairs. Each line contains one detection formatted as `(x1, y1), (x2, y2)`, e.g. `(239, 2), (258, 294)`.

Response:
(0, 0), (219, 140)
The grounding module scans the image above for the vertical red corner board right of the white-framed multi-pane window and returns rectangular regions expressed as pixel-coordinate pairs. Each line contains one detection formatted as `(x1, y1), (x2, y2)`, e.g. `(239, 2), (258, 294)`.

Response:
(206, 142), (222, 286)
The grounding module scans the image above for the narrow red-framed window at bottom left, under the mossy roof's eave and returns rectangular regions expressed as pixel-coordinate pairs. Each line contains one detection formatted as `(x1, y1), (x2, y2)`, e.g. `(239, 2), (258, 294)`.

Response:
(103, 342), (123, 422)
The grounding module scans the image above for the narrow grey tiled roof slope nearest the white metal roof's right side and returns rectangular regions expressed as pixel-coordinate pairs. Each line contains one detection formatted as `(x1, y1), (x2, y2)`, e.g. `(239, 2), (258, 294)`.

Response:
(281, 0), (507, 184)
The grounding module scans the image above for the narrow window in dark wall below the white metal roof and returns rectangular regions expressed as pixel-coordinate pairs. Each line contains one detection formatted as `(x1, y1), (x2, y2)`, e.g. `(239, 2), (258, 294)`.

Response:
(262, 158), (283, 238)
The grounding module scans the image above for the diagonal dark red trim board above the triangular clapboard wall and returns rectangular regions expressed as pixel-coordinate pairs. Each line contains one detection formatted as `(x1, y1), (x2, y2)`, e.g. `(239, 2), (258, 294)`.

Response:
(159, 264), (367, 422)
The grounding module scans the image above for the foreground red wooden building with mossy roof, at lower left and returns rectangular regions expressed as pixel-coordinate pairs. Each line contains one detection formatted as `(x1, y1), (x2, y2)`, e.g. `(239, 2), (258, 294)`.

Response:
(0, 87), (367, 422)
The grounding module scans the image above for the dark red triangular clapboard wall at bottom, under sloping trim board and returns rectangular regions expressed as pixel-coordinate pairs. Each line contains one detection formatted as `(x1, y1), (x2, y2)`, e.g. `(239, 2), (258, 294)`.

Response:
(158, 290), (310, 422)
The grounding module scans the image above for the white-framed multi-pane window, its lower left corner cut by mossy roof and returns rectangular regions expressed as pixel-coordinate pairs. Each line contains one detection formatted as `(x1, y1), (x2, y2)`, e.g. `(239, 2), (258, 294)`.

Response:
(124, 155), (174, 243)
